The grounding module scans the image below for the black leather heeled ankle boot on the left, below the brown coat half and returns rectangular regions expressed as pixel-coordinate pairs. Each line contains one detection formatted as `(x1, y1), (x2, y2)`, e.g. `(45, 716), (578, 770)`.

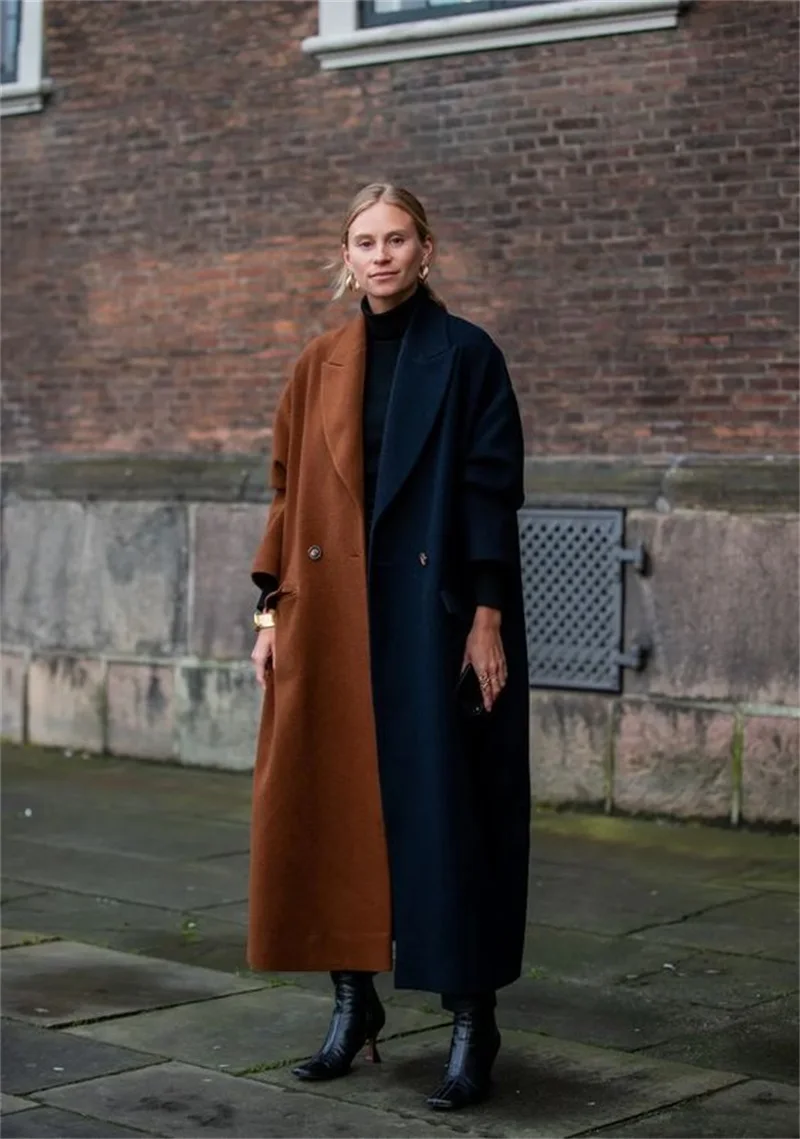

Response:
(292, 973), (386, 1080)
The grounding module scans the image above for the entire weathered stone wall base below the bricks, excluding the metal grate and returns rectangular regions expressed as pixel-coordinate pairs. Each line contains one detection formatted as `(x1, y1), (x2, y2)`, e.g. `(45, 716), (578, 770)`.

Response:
(0, 456), (800, 825)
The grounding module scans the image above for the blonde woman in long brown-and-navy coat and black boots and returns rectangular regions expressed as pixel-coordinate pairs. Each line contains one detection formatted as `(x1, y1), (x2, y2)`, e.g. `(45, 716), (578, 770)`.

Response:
(248, 185), (530, 1109)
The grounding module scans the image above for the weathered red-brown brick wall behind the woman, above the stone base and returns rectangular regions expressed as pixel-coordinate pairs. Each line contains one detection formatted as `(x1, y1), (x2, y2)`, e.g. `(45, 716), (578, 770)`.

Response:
(2, 0), (798, 456)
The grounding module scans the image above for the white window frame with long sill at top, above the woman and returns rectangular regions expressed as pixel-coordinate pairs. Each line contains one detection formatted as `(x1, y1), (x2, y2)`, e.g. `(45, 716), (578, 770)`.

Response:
(302, 0), (685, 71)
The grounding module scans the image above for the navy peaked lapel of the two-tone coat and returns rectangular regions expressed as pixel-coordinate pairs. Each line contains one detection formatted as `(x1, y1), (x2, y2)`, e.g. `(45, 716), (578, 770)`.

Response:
(373, 297), (455, 525)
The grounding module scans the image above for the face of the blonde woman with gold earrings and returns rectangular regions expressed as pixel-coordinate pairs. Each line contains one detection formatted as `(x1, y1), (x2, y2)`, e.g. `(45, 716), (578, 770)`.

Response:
(342, 202), (433, 312)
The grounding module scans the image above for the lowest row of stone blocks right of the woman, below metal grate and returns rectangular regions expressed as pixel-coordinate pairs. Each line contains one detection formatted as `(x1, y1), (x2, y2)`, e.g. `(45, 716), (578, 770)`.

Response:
(531, 691), (800, 826)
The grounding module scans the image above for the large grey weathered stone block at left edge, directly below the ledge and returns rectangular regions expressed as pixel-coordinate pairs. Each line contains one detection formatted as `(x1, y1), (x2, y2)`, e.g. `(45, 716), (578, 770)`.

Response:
(2, 500), (188, 655)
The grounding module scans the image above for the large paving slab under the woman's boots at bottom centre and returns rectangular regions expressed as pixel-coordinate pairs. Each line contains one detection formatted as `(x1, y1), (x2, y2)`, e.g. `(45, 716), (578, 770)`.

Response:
(256, 1029), (736, 1139)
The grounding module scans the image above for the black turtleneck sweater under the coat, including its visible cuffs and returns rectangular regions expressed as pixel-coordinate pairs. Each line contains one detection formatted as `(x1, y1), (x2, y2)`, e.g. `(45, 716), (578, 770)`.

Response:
(259, 288), (504, 609)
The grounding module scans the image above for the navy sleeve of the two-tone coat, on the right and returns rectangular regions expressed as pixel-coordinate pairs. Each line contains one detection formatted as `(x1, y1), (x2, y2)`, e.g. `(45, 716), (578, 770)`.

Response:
(462, 343), (525, 566)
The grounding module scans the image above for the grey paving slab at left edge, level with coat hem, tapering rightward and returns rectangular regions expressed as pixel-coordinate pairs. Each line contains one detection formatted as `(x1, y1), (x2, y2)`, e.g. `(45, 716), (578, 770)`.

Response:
(0, 941), (263, 1025)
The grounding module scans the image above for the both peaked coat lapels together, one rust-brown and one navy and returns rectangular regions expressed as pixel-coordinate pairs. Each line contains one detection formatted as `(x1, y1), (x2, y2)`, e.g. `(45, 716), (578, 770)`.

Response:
(323, 289), (455, 526)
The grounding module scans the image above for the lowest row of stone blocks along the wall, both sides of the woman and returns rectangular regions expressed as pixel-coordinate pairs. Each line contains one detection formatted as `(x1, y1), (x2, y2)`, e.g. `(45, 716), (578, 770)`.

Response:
(0, 649), (800, 826)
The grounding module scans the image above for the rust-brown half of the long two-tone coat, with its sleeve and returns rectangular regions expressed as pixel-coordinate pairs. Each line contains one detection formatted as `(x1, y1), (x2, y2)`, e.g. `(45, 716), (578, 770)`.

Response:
(247, 317), (391, 970)
